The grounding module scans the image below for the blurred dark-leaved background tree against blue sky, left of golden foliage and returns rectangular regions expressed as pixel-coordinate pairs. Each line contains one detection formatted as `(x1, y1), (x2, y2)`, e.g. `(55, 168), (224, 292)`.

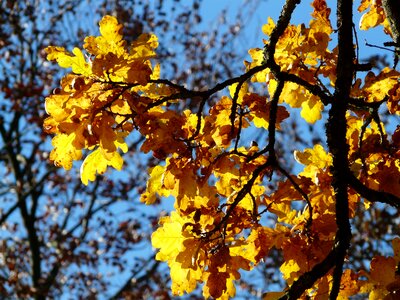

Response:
(0, 0), (272, 299)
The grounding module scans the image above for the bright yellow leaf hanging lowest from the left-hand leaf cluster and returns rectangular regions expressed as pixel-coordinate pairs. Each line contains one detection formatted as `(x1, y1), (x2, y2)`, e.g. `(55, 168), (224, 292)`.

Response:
(80, 148), (124, 185)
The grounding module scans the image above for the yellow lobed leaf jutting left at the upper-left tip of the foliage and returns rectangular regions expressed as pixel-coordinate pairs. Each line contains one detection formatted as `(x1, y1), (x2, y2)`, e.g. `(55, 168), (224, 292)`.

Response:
(45, 46), (92, 76)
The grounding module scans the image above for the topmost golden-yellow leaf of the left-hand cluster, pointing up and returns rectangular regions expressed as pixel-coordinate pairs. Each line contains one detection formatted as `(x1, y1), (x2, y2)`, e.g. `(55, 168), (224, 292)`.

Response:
(83, 16), (126, 56)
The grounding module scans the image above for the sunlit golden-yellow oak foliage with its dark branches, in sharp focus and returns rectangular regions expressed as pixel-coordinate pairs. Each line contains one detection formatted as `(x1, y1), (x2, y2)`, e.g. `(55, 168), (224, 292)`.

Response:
(44, 0), (400, 299)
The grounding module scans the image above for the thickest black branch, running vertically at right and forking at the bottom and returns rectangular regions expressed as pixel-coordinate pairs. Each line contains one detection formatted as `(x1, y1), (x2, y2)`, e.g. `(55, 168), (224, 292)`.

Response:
(281, 0), (355, 299)
